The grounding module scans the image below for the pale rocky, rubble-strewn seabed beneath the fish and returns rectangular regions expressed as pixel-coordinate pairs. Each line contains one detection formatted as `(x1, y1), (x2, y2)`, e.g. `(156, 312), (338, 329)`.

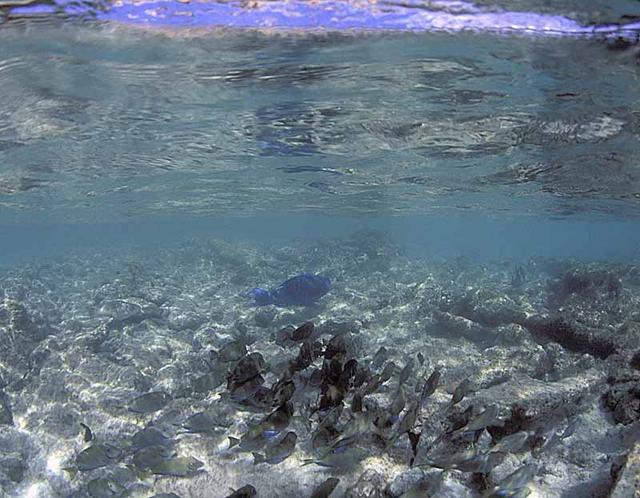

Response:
(0, 232), (640, 498)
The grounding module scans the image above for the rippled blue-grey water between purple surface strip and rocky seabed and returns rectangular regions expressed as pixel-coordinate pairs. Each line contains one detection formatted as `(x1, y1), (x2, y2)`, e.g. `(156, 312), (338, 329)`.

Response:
(0, 16), (640, 262)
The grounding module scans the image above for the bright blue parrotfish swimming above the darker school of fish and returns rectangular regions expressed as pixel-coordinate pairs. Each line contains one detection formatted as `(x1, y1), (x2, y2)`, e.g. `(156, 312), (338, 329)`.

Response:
(246, 273), (331, 307)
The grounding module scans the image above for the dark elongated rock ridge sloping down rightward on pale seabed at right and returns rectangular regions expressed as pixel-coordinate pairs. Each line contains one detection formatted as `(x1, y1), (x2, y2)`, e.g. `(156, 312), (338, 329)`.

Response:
(524, 315), (617, 358)
